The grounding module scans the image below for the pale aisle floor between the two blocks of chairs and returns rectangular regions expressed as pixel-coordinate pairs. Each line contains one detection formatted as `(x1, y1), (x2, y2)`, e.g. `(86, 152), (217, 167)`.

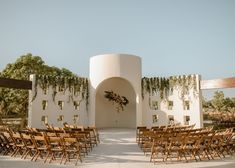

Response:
(81, 128), (153, 168)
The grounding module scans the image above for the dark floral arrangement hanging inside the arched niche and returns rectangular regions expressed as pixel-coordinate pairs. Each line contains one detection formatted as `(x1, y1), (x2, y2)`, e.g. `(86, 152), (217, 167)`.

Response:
(104, 90), (129, 112)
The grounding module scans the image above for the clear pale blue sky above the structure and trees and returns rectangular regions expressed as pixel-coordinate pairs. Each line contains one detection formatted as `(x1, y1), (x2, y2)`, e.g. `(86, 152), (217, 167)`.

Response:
(0, 0), (235, 98)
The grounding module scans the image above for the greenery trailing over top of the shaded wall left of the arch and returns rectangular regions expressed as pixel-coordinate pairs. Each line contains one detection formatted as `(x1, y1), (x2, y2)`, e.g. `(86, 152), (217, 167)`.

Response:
(32, 75), (89, 108)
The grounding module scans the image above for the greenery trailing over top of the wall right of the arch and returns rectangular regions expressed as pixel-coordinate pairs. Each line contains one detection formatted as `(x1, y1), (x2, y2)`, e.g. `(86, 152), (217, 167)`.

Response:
(141, 75), (198, 99)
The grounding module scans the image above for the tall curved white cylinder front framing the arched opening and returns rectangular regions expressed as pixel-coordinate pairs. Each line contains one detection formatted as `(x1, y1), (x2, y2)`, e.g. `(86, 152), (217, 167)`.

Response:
(89, 54), (142, 125)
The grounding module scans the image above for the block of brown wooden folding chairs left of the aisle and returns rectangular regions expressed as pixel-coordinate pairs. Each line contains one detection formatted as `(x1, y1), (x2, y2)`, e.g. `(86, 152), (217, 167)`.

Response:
(0, 124), (99, 165)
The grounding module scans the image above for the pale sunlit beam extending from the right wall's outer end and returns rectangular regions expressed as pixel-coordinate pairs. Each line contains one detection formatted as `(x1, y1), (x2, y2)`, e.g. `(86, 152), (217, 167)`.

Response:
(200, 77), (235, 89)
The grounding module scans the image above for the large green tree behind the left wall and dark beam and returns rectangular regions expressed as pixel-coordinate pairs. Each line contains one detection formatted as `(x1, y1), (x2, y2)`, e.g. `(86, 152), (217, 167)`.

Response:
(0, 53), (74, 128)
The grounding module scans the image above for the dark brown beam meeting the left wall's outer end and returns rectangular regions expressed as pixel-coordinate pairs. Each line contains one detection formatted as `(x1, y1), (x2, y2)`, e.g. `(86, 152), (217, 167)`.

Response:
(0, 77), (32, 90)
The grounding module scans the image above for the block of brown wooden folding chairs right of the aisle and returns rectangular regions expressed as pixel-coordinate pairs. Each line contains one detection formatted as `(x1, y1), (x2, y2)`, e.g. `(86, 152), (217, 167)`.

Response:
(137, 125), (235, 163)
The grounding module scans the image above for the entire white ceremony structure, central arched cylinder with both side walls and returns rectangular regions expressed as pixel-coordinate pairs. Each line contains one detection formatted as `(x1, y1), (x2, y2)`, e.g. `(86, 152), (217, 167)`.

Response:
(28, 54), (202, 128)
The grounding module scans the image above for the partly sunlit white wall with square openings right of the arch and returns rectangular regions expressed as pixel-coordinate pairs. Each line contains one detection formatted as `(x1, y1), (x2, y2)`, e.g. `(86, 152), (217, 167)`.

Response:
(142, 75), (203, 128)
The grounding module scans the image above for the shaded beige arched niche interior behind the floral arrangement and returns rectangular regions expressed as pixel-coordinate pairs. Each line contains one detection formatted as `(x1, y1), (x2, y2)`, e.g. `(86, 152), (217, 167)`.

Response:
(95, 77), (136, 128)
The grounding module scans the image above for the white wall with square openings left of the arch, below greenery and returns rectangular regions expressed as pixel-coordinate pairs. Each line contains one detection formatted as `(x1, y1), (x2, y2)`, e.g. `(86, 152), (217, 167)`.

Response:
(28, 75), (88, 128)
